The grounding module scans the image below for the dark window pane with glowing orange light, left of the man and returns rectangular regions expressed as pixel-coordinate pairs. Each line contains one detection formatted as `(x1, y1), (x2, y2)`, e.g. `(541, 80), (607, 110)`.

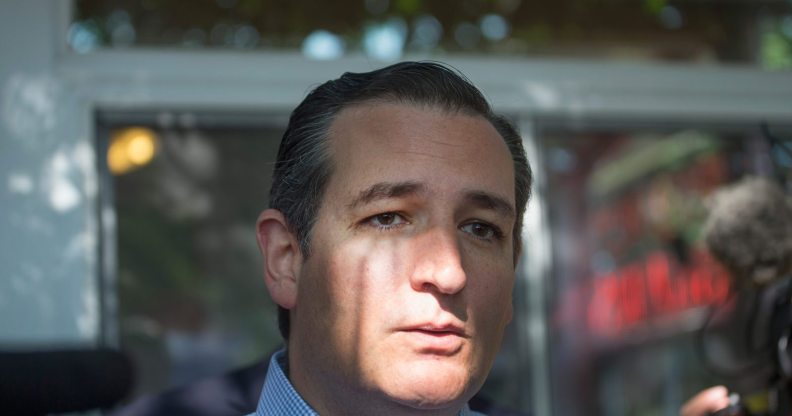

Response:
(109, 118), (282, 395)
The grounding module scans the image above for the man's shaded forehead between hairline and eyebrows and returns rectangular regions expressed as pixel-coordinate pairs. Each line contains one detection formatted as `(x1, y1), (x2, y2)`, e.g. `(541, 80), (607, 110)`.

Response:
(330, 103), (514, 202)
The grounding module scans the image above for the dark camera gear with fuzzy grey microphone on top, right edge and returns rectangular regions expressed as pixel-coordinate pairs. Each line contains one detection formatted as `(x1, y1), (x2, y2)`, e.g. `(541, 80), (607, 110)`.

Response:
(699, 176), (792, 416)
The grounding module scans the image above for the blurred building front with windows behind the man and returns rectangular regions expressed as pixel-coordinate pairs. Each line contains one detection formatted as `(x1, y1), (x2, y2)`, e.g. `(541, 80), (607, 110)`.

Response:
(0, 0), (792, 416)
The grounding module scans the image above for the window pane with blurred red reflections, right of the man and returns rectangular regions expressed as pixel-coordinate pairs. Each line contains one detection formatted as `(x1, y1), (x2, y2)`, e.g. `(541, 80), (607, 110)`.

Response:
(540, 127), (792, 415)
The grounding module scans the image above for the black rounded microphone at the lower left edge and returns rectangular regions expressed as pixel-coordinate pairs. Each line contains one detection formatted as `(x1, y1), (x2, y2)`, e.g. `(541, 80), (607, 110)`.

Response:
(0, 348), (133, 415)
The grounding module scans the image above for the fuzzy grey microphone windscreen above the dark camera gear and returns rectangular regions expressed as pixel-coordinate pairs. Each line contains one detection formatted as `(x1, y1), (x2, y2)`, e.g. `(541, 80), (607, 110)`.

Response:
(704, 177), (792, 286)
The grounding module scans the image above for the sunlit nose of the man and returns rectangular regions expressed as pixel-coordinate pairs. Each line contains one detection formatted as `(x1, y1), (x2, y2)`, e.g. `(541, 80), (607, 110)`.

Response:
(410, 230), (467, 295)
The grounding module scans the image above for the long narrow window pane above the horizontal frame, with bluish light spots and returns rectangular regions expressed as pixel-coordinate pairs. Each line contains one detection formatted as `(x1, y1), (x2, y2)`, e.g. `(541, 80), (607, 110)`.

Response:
(69, 0), (792, 69)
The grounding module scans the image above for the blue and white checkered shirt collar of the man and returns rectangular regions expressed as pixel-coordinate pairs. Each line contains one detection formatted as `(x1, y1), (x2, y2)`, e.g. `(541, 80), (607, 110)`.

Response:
(248, 350), (484, 416)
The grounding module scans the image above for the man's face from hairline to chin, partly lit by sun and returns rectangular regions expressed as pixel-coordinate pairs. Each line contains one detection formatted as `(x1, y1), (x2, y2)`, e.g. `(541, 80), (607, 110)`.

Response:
(289, 103), (515, 410)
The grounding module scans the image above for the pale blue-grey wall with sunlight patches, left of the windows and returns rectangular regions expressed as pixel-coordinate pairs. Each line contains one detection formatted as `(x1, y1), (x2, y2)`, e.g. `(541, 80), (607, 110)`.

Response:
(0, 0), (99, 345)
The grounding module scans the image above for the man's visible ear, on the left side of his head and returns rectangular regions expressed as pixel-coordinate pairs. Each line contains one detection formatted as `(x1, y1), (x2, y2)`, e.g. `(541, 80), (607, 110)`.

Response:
(256, 209), (302, 309)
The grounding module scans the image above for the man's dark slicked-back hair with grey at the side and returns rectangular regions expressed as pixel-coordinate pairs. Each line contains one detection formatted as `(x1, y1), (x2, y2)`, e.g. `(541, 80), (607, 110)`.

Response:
(270, 62), (533, 340)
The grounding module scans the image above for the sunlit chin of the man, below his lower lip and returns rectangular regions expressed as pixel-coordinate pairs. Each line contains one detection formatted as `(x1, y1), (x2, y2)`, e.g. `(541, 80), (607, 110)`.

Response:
(385, 360), (481, 409)
